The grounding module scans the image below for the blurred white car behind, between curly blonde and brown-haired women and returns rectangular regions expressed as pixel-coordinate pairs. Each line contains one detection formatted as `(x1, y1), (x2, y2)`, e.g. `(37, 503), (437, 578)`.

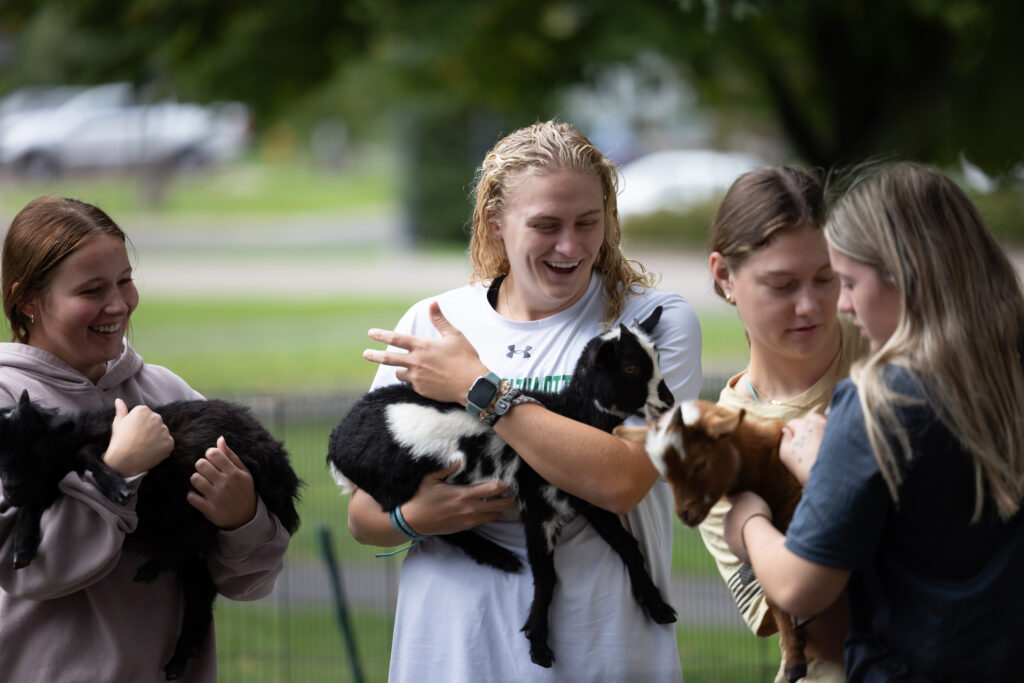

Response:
(618, 150), (766, 218)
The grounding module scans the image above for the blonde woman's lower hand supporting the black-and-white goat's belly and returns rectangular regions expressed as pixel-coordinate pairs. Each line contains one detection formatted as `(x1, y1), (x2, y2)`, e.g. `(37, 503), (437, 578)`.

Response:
(402, 463), (517, 536)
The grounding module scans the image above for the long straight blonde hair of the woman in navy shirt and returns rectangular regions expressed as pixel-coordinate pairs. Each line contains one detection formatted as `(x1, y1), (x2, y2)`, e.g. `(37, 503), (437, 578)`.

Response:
(825, 162), (1024, 520)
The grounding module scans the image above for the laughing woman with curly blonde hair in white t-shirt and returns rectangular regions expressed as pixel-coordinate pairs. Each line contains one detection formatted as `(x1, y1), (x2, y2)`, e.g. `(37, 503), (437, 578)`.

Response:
(349, 122), (700, 683)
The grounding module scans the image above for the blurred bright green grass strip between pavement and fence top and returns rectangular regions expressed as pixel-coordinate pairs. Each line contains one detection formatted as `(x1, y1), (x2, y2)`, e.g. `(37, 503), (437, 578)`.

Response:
(132, 297), (746, 396)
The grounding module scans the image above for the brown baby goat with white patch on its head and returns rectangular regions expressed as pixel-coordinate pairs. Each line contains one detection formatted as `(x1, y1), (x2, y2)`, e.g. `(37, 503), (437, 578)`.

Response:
(614, 400), (807, 681)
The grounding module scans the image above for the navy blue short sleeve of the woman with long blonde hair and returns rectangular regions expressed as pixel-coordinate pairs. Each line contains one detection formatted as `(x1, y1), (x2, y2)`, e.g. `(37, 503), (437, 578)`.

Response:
(785, 380), (892, 570)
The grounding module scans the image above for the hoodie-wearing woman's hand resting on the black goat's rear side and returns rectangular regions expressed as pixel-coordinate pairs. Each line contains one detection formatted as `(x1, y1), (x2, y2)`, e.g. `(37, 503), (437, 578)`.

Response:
(186, 436), (256, 529)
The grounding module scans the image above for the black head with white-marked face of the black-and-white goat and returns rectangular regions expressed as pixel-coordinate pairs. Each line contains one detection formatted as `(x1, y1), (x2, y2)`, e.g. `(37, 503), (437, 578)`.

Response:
(573, 306), (675, 420)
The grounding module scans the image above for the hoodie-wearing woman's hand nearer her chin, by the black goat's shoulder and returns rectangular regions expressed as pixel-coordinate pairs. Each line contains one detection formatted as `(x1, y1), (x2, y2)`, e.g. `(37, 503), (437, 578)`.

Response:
(103, 398), (174, 477)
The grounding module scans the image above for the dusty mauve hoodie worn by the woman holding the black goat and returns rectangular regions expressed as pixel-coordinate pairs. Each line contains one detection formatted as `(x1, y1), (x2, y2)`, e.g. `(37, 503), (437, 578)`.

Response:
(0, 340), (289, 683)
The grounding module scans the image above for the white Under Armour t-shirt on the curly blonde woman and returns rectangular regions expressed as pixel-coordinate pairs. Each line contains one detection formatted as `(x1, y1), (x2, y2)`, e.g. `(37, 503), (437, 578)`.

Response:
(374, 276), (700, 683)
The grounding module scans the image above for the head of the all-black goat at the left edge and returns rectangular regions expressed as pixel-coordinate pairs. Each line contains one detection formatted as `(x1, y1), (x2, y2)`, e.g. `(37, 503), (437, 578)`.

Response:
(0, 390), (74, 506)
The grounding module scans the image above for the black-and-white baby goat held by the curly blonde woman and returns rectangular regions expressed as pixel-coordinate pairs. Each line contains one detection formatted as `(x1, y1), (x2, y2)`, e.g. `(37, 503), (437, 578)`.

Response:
(328, 306), (676, 667)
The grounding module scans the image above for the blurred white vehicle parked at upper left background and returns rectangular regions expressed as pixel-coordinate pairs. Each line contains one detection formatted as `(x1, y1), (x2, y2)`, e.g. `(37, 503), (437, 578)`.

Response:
(0, 83), (251, 177)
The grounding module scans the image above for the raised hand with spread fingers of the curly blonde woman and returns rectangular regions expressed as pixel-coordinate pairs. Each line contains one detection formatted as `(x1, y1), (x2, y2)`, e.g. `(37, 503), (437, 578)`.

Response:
(362, 301), (487, 405)
